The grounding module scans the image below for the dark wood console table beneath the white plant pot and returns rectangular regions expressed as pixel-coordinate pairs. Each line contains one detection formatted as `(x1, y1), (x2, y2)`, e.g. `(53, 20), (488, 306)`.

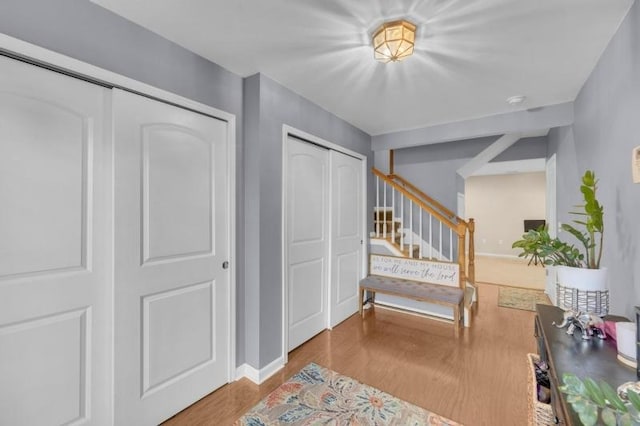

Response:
(535, 305), (638, 426)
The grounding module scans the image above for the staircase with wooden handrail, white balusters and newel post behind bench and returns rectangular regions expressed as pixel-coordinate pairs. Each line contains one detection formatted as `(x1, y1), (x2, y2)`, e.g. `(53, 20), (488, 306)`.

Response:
(371, 168), (477, 324)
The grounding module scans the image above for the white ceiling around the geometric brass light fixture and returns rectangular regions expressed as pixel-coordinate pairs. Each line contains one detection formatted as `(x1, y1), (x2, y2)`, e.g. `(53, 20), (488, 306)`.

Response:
(92, 0), (633, 135)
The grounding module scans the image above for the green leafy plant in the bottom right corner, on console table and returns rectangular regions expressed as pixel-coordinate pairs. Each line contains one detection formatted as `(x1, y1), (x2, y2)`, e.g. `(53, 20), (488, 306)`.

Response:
(558, 373), (640, 426)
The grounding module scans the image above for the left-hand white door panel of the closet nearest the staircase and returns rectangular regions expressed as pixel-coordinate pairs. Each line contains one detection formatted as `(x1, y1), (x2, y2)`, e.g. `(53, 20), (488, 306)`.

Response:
(285, 137), (329, 350)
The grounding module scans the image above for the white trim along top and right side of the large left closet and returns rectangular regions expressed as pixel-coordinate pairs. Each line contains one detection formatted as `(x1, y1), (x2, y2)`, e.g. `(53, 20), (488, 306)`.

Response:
(0, 33), (237, 384)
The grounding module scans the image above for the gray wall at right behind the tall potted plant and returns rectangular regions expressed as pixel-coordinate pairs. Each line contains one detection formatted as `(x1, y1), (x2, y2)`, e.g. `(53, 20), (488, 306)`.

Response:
(549, 2), (640, 318)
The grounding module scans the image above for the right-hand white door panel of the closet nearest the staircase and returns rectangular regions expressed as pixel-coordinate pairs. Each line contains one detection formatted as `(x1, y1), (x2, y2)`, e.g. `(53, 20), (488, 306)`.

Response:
(329, 151), (363, 327)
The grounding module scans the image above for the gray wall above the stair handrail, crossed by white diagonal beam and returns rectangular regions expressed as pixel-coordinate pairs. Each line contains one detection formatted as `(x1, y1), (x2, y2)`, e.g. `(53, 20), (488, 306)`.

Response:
(375, 136), (547, 212)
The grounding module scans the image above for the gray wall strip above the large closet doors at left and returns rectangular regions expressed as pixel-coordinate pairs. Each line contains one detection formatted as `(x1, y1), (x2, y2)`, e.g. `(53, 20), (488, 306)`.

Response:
(0, 0), (242, 116)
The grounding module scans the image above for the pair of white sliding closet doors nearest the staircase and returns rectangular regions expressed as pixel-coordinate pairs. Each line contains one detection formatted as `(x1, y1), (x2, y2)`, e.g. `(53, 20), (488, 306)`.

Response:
(285, 136), (363, 350)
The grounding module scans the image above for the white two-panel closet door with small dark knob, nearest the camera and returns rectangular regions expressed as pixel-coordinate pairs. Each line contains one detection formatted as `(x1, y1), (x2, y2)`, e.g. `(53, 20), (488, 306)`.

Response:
(113, 90), (230, 425)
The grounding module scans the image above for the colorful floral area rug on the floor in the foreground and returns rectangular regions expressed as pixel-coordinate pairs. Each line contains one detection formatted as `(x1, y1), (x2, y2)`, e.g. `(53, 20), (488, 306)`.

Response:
(235, 363), (459, 426)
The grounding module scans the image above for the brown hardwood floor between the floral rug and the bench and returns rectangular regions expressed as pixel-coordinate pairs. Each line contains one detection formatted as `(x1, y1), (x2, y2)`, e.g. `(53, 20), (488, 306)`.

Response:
(165, 284), (536, 426)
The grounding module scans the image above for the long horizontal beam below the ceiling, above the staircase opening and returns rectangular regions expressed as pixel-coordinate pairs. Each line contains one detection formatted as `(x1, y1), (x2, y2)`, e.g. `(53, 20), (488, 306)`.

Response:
(371, 102), (573, 151)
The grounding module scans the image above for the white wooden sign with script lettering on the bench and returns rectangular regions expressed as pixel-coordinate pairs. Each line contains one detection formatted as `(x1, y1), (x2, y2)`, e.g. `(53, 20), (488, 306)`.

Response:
(369, 254), (460, 287)
